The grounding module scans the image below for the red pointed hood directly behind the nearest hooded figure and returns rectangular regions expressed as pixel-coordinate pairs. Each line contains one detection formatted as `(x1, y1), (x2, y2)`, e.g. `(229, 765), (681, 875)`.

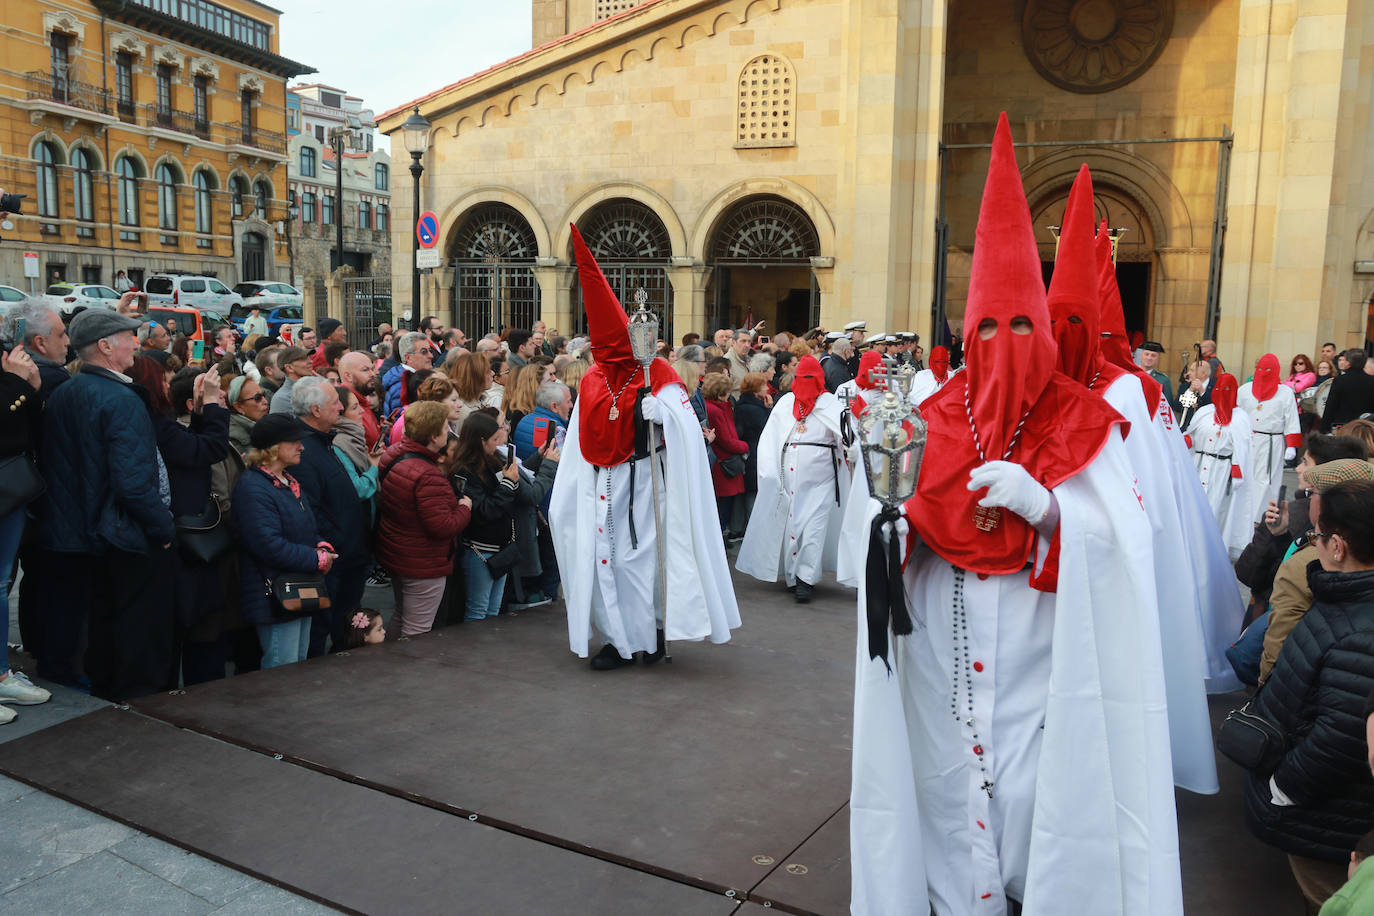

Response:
(1048, 163), (1103, 387)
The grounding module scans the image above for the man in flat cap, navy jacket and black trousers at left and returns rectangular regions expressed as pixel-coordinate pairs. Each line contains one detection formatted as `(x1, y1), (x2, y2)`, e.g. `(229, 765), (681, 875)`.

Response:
(38, 309), (176, 700)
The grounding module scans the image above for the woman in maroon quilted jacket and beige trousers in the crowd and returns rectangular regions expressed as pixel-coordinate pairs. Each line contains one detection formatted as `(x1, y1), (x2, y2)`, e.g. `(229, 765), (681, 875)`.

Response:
(376, 401), (473, 636)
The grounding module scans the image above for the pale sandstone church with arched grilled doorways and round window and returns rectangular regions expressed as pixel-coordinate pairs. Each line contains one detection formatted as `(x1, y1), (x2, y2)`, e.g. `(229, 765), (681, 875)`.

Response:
(379, 0), (1374, 376)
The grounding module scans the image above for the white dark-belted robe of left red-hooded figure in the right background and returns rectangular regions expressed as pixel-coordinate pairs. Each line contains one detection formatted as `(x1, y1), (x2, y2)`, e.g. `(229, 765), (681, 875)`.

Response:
(1186, 404), (1254, 563)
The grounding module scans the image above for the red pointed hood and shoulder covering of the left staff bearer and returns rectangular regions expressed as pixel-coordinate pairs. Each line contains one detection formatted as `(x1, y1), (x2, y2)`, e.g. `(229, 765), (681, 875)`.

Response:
(573, 225), (682, 467)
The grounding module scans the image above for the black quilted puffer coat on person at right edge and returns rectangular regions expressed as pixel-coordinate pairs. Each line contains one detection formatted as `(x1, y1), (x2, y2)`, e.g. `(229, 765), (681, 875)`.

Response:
(1245, 562), (1374, 862)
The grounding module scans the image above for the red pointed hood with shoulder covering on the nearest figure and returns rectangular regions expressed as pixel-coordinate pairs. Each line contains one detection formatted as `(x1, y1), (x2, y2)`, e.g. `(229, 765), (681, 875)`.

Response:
(905, 114), (1124, 591)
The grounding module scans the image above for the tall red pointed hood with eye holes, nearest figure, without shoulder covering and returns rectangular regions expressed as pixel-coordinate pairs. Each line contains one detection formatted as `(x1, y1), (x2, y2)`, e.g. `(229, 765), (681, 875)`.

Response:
(963, 113), (1055, 460)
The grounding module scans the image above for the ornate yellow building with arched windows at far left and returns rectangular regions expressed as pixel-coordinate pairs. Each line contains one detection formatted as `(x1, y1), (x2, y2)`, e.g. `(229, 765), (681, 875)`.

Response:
(0, 0), (313, 293)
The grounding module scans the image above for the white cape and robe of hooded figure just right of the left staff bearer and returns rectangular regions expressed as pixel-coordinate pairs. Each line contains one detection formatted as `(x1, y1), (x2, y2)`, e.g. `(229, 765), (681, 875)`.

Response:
(735, 391), (851, 585)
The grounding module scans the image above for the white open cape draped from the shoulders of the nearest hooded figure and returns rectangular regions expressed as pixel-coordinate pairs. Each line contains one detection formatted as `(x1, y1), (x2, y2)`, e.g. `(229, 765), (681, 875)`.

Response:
(845, 437), (1183, 916)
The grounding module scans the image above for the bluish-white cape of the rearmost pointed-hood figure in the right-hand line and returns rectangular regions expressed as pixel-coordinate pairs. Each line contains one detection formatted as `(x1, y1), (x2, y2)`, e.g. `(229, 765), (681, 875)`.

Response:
(1154, 394), (1245, 694)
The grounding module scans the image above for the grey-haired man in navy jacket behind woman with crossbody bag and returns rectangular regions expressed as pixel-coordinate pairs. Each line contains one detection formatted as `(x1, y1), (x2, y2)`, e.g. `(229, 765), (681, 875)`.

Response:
(291, 376), (372, 658)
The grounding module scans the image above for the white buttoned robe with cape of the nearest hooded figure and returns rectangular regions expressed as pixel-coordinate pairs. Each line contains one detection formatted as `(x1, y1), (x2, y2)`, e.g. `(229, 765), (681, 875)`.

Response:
(845, 435), (1183, 916)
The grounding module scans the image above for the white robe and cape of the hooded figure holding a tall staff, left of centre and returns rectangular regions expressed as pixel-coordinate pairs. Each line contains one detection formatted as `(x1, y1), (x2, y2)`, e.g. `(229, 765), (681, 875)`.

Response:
(548, 385), (739, 658)
